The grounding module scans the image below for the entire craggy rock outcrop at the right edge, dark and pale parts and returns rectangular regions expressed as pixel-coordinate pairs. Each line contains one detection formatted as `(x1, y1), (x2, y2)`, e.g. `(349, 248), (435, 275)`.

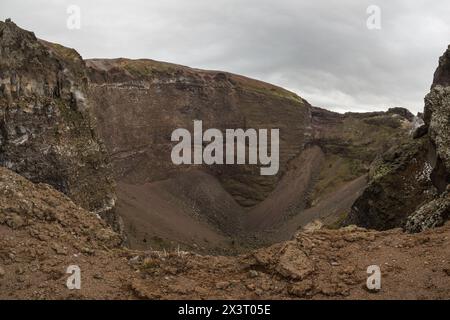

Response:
(344, 48), (450, 232)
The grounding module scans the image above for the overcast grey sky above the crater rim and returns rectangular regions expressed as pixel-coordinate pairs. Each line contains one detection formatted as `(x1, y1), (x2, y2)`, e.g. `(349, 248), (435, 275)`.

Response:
(0, 0), (450, 113)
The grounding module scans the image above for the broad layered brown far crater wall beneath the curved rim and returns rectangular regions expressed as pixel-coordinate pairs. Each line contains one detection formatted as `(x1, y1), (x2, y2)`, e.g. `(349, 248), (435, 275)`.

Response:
(87, 59), (310, 206)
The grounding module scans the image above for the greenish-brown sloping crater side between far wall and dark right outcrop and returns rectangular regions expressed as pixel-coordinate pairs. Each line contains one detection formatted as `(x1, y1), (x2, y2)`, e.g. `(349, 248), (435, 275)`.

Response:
(236, 107), (413, 235)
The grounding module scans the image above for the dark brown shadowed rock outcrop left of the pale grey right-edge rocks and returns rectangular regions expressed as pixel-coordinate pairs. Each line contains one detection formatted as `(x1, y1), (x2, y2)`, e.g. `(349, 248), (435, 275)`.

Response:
(343, 137), (435, 230)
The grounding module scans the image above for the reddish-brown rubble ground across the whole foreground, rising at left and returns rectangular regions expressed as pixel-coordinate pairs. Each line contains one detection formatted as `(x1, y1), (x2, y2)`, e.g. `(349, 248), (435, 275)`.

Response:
(0, 168), (450, 299)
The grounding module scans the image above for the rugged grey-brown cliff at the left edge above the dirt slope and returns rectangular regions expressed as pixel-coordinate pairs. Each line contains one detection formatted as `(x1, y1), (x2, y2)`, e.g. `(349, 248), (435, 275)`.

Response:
(0, 21), (115, 222)
